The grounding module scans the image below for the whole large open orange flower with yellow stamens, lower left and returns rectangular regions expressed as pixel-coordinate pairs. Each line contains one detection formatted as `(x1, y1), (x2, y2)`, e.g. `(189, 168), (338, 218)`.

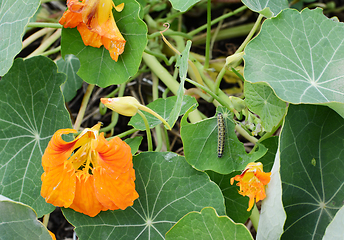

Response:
(41, 123), (139, 217)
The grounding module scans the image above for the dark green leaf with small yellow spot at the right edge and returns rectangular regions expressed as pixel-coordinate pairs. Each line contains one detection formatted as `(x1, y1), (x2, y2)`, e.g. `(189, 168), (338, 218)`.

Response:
(280, 105), (344, 240)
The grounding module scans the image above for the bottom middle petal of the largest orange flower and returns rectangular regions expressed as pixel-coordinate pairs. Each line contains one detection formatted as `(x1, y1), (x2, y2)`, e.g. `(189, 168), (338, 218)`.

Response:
(69, 176), (107, 217)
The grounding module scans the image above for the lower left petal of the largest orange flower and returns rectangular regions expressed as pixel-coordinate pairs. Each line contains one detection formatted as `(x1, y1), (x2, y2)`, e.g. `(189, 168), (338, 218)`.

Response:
(41, 163), (76, 207)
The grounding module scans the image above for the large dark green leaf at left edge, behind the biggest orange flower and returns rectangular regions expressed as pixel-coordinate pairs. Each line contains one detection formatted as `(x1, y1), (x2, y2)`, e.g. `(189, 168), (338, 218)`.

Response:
(0, 57), (71, 216)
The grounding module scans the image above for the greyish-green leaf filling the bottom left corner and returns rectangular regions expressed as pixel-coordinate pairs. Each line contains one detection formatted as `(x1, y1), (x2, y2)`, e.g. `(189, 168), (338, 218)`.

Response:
(0, 201), (52, 240)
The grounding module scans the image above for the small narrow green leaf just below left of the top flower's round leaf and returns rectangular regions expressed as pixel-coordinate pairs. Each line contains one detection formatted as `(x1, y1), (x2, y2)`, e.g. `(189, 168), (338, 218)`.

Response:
(56, 54), (83, 102)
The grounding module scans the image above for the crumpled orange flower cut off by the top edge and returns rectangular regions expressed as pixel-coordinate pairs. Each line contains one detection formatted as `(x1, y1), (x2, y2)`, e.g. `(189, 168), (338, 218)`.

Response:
(59, 0), (126, 62)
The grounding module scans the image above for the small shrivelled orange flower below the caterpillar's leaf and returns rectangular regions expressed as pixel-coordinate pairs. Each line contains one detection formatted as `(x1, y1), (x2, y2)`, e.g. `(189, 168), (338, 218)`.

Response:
(230, 162), (271, 211)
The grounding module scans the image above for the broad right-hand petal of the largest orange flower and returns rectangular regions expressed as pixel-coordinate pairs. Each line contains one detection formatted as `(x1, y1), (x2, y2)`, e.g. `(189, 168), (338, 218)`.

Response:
(93, 134), (139, 210)
